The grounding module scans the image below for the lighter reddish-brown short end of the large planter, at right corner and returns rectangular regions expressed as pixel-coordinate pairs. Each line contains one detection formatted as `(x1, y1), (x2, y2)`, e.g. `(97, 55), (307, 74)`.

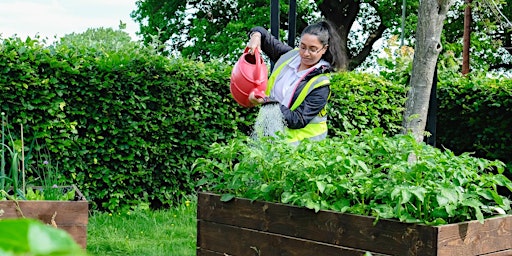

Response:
(438, 216), (512, 256)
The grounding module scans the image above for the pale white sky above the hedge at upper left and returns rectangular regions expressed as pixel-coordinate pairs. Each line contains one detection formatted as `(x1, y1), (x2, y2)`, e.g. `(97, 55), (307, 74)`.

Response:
(0, 0), (138, 41)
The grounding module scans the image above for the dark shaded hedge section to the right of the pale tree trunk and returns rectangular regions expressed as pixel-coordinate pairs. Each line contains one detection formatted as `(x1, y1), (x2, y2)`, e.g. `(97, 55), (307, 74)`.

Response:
(436, 75), (512, 170)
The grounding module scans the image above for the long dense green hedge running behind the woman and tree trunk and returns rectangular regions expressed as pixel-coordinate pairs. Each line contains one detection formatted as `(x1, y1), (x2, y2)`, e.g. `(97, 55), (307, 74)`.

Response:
(0, 29), (512, 211)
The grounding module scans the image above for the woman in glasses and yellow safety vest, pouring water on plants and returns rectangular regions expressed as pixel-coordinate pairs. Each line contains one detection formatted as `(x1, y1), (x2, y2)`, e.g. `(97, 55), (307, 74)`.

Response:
(247, 21), (347, 143)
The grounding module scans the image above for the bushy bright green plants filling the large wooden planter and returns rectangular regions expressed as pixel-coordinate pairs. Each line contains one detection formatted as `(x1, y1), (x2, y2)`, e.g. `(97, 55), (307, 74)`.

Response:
(194, 129), (512, 225)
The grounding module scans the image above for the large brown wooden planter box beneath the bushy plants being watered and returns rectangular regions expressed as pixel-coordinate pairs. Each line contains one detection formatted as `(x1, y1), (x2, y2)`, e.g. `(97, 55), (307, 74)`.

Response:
(197, 192), (512, 256)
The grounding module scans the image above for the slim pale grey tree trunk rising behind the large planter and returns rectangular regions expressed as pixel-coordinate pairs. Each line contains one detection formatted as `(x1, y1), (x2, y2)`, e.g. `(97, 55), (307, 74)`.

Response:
(403, 0), (454, 142)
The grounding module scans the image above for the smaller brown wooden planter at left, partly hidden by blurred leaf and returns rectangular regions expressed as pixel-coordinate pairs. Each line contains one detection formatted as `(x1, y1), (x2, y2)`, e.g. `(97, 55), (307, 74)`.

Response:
(0, 186), (89, 249)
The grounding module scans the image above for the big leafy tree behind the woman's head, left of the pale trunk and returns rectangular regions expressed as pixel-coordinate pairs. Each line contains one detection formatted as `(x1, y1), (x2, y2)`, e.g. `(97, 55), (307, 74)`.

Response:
(131, 0), (417, 70)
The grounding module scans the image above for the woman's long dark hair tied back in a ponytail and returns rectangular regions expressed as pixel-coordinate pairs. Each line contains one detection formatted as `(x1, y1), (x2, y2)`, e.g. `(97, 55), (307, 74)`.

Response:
(300, 20), (347, 70)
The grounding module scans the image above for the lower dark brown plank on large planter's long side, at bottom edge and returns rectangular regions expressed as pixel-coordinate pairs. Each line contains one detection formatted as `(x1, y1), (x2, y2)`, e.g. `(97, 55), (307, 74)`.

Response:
(198, 221), (390, 256)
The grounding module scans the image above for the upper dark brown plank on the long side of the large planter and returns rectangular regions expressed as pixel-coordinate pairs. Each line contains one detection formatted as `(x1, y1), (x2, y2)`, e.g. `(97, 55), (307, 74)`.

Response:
(197, 192), (437, 256)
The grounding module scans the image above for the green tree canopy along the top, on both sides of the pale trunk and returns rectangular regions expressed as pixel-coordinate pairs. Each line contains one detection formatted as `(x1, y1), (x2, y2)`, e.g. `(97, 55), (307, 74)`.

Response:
(131, 0), (512, 70)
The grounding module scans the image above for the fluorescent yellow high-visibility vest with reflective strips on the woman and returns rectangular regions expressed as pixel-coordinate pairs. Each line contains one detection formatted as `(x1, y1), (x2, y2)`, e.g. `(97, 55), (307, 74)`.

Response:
(265, 49), (329, 144)
